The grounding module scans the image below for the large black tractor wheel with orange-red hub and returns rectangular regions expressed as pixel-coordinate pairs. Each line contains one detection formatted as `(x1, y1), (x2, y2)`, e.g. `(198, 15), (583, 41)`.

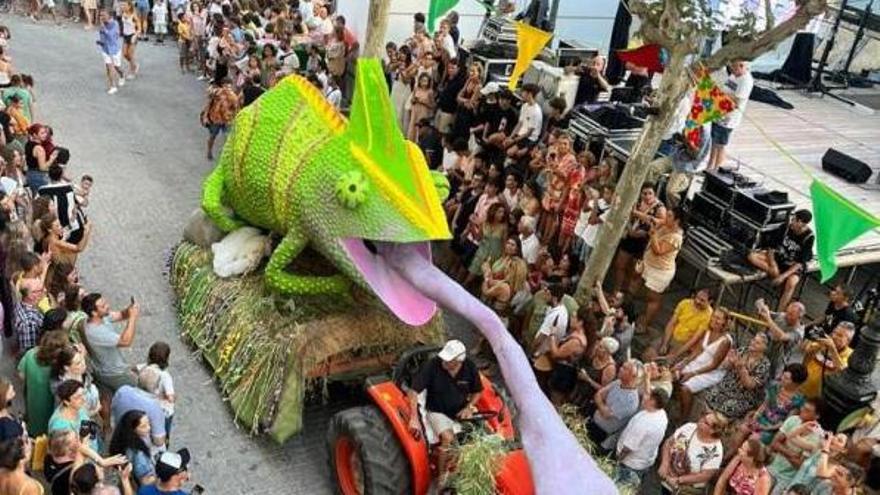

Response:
(327, 406), (412, 495)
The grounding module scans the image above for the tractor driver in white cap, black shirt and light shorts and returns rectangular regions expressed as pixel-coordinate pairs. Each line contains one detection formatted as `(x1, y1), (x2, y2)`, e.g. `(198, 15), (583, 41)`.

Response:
(407, 340), (483, 486)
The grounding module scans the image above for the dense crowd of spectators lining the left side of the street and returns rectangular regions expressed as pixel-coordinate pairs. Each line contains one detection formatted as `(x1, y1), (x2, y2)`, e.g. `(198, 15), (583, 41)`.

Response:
(0, 27), (189, 495)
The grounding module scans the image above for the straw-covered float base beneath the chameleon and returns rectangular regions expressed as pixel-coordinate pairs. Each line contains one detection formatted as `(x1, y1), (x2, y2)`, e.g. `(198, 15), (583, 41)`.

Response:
(170, 242), (443, 442)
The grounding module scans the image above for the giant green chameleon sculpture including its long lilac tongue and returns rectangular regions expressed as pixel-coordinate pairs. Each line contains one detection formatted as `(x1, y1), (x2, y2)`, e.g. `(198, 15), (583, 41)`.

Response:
(202, 59), (616, 495)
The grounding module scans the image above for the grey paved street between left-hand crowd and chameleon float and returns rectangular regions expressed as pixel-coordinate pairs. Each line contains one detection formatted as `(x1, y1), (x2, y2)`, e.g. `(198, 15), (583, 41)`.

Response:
(0, 16), (330, 495)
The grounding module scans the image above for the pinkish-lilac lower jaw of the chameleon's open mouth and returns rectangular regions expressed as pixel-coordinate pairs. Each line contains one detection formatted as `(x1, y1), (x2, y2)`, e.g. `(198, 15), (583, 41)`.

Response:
(341, 238), (437, 326)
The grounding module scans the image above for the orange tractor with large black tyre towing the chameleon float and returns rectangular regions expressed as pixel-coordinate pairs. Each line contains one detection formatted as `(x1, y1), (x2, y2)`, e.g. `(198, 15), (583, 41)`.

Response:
(327, 347), (534, 495)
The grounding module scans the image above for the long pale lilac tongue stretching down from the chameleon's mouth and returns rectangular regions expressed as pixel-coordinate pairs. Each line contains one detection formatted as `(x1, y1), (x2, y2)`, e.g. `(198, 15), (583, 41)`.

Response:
(376, 243), (617, 495)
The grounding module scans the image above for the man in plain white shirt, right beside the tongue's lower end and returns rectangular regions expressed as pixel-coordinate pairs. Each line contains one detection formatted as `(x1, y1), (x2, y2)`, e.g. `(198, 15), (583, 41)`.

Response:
(615, 388), (669, 486)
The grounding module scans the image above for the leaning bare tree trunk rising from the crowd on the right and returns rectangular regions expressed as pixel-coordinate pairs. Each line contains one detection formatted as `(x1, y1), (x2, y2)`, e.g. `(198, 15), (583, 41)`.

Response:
(575, 48), (692, 305)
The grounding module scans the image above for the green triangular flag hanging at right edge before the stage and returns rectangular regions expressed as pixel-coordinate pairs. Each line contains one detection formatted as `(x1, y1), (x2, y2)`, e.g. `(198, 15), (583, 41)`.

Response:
(810, 179), (880, 282)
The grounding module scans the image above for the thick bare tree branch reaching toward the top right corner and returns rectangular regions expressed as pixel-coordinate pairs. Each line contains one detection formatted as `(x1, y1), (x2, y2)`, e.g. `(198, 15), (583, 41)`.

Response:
(692, 0), (828, 71)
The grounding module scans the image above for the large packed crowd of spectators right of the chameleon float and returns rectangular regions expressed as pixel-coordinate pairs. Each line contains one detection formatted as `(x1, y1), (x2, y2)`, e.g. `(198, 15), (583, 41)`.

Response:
(344, 7), (868, 495)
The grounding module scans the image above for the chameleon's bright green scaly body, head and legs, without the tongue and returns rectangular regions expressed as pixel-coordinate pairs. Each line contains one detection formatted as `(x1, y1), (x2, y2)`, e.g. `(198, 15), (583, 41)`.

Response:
(202, 59), (450, 295)
